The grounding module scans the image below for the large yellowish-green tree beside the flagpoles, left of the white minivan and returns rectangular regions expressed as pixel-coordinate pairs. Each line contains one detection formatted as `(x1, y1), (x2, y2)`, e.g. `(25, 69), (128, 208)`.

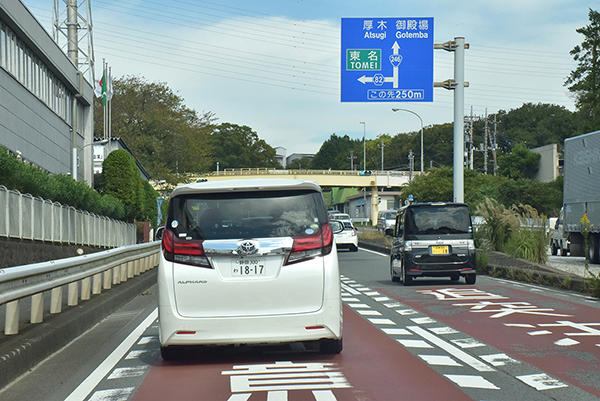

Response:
(94, 76), (214, 182)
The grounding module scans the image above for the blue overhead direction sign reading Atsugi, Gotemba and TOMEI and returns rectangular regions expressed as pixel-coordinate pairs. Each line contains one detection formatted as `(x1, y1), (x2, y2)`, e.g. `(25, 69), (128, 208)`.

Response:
(341, 17), (433, 102)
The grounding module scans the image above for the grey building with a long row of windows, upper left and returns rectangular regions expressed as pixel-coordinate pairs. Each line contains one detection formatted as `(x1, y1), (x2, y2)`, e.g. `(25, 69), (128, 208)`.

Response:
(0, 0), (94, 185)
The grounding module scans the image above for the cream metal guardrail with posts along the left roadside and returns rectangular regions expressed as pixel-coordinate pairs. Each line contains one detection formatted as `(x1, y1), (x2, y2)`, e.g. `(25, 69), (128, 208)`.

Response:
(0, 241), (160, 335)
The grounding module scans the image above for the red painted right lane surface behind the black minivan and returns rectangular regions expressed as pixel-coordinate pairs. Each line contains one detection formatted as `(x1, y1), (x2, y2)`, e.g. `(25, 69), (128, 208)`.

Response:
(378, 285), (600, 397)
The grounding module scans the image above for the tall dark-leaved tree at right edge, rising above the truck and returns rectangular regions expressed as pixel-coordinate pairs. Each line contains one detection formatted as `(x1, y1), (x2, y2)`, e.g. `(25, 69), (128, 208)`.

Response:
(565, 8), (600, 130)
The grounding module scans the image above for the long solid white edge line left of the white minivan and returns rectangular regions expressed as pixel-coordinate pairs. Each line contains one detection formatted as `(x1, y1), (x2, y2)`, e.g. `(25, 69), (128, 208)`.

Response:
(65, 308), (158, 401)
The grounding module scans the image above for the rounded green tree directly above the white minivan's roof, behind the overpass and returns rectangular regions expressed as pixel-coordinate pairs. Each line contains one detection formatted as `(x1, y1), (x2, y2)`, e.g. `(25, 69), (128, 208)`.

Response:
(210, 123), (281, 170)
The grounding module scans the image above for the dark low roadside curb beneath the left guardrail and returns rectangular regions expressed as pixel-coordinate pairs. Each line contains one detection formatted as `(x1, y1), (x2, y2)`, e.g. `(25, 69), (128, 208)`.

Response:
(0, 268), (157, 389)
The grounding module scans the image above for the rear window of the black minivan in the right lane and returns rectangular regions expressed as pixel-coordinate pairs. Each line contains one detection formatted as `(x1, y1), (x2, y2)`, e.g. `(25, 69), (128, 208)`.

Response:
(405, 205), (472, 235)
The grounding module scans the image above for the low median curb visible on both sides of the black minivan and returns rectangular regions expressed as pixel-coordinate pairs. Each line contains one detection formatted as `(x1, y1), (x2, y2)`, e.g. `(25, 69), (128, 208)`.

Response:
(358, 240), (588, 293)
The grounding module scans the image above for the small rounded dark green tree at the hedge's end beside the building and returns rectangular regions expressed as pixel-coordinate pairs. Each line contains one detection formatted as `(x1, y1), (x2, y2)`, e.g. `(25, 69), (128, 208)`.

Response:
(102, 149), (142, 222)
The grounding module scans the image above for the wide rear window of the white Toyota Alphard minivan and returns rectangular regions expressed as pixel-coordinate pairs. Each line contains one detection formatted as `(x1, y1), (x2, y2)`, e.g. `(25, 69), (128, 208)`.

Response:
(167, 190), (327, 240)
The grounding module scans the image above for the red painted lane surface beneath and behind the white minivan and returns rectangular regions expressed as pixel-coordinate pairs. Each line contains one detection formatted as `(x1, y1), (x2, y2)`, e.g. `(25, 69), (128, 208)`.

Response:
(134, 307), (471, 401)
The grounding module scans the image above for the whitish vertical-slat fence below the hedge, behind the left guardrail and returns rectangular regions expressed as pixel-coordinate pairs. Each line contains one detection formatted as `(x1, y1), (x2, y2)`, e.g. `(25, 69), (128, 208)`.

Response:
(0, 185), (136, 247)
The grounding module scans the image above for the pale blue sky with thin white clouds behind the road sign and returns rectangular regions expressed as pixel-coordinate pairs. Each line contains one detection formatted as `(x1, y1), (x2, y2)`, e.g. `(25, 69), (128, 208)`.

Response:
(23, 0), (599, 155)
